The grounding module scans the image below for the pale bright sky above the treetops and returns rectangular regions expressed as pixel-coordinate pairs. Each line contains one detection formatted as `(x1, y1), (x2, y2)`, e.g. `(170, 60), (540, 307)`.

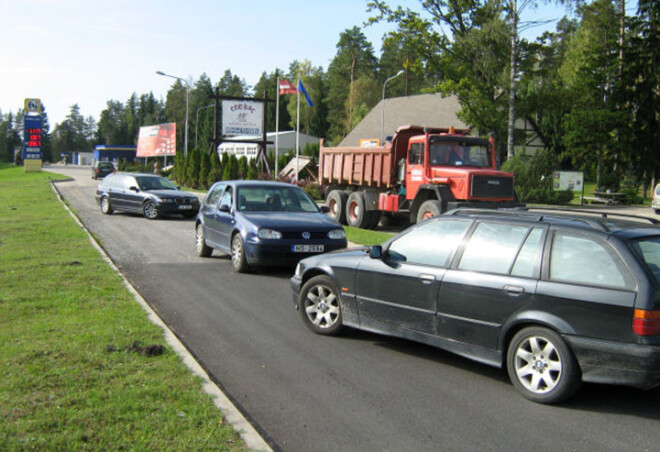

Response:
(0, 0), (564, 130)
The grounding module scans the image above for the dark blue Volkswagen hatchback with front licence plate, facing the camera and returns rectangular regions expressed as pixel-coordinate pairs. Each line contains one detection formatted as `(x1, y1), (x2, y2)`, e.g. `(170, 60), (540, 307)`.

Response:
(195, 180), (346, 272)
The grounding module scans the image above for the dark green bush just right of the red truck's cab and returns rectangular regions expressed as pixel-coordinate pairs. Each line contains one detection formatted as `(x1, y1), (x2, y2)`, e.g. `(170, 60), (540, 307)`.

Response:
(502, 150), (573, 204)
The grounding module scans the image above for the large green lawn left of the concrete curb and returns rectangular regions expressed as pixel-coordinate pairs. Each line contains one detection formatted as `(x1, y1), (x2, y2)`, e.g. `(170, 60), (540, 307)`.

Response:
(0, 164), (246, 451)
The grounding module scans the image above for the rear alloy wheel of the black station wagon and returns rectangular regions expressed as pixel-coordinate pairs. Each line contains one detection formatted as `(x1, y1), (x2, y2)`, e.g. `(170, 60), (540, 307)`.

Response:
(507, 327), (582, 403)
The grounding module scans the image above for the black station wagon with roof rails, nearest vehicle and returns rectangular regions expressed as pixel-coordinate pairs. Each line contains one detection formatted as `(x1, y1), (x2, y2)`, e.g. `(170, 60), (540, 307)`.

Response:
(291, 209), (660, 403)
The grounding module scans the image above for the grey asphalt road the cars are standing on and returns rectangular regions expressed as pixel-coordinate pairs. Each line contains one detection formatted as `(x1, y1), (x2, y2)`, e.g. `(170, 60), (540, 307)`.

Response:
(46, 166), (660, 452)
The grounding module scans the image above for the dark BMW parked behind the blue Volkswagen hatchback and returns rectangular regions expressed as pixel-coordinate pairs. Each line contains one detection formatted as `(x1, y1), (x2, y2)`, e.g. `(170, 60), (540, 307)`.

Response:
(96, 172), (199, 220)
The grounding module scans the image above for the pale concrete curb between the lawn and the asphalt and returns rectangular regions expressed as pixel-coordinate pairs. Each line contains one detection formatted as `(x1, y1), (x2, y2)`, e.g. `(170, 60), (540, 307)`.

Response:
(50, 181), (273, 452)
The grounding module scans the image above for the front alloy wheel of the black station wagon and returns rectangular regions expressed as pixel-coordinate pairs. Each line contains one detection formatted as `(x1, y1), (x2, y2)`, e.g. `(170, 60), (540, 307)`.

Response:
(298, 275), (344, 335)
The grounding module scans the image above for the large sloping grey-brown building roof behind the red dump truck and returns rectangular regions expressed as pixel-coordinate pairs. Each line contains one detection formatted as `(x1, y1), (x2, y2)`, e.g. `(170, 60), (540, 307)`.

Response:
(339, 94), (468, 146)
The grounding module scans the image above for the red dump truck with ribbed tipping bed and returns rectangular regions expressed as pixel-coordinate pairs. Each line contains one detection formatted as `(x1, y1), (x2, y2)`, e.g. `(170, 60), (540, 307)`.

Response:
(319, 126), (522, 229)
